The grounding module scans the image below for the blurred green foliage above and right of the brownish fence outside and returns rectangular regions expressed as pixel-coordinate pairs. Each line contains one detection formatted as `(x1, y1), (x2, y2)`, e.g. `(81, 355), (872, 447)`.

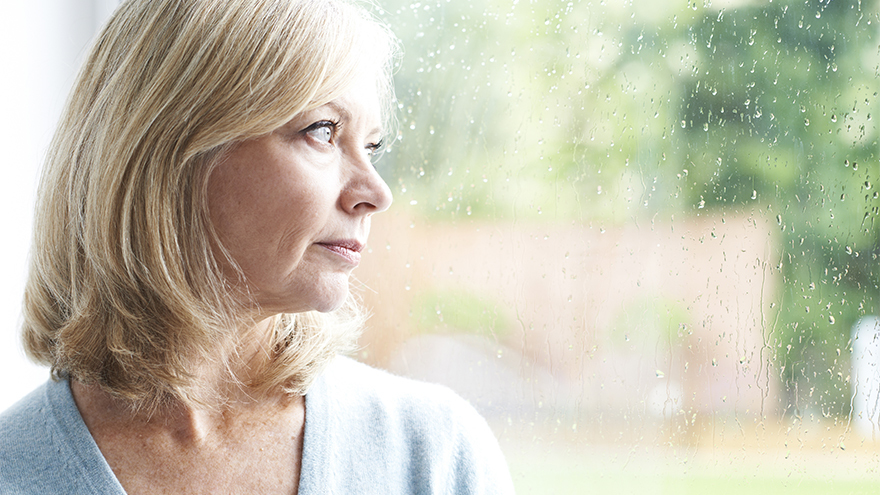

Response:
(382, 0), (880, 415)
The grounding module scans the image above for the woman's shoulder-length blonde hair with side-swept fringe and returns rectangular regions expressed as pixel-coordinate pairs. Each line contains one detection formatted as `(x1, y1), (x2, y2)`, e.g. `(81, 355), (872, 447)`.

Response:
(23, 0), (396, 408)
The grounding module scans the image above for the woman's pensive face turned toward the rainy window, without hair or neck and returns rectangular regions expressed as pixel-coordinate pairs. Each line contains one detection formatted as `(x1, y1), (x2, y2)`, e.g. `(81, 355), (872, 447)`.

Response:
(208, 72), (391, 316)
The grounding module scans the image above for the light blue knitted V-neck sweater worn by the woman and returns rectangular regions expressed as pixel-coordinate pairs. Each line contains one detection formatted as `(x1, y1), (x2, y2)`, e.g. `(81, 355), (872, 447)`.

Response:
(0, 358), (513, 495)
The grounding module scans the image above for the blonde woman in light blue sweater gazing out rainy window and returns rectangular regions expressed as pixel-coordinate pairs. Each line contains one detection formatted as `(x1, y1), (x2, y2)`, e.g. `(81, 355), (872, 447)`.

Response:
(0, 0), (511, 494)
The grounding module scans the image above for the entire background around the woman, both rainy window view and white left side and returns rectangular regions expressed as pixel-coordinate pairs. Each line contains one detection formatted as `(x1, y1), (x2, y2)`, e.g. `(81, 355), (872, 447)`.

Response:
(0, 0), (880, 494)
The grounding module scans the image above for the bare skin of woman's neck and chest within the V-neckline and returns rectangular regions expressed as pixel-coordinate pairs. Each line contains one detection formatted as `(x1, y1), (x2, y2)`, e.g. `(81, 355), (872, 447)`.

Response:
(71, 320), (305, 495)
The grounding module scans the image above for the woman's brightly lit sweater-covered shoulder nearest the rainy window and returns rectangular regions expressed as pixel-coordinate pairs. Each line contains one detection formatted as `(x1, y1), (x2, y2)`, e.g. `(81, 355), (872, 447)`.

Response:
(306, 358), (512, 494)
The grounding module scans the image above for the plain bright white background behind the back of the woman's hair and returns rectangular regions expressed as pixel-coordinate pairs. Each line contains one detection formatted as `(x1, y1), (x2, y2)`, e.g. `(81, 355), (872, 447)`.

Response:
(0, 0), (119, 410)
